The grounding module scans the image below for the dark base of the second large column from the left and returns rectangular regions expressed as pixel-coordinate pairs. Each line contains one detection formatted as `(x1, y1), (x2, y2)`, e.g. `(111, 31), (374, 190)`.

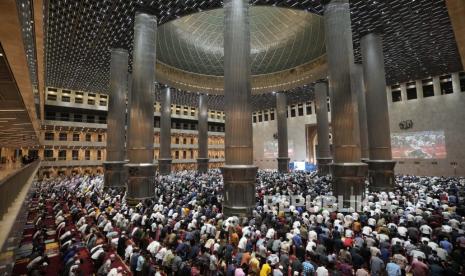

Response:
(124, 163), (156, 206)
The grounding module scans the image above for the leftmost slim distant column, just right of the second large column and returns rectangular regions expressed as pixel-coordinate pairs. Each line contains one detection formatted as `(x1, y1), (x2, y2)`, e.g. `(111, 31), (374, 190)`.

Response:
(158, 87), (171, 175)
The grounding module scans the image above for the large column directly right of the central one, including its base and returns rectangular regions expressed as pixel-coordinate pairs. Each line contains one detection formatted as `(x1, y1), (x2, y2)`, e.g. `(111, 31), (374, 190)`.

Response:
(324, 0), (367, 207)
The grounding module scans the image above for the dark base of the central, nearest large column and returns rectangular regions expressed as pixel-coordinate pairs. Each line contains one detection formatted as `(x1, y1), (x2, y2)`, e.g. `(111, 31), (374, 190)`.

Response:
(221, 165), (258, 217)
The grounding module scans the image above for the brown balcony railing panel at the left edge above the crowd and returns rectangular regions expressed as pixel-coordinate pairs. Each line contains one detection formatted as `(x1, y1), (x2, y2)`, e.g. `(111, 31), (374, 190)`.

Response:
(0, 160), (40, 219)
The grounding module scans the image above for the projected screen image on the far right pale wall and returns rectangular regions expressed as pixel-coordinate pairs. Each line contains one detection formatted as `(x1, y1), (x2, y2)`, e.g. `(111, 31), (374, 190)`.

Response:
(391, 131), (447, 159)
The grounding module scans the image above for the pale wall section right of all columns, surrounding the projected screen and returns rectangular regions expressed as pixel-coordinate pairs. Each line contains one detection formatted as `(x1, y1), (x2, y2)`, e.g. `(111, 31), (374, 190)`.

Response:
(389, 92), (465, 176)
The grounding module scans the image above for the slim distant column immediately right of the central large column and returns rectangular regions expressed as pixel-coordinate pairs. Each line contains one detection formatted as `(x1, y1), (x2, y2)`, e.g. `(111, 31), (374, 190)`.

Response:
(276, 92), (290, 173)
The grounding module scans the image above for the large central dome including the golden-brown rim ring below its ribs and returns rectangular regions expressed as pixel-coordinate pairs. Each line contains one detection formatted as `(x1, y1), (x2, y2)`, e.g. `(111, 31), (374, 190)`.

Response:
(157, 6), (325, 94)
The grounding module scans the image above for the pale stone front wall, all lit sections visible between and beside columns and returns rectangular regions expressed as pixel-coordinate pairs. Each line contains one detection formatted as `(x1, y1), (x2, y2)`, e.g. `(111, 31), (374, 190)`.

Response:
(253, 89), (465, 176)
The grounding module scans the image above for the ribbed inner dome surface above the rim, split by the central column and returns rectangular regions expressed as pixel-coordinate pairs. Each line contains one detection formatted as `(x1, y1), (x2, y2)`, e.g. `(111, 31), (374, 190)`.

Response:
(157, 6), (325, 76)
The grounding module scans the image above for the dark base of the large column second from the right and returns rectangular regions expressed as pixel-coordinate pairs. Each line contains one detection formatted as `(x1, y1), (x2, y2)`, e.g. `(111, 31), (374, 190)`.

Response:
(330, 163), (368, 209)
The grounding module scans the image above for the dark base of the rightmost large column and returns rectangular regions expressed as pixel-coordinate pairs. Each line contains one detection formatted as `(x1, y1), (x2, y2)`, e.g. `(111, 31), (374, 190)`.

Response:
(366, 160), (396, 192)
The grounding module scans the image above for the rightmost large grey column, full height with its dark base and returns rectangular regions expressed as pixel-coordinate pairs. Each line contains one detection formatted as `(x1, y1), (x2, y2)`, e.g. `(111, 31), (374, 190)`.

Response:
(360, 33), (396, 191)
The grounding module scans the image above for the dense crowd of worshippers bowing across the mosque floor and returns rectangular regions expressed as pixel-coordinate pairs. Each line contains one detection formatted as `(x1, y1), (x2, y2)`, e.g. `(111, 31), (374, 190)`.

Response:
(26, 170), (465, 276)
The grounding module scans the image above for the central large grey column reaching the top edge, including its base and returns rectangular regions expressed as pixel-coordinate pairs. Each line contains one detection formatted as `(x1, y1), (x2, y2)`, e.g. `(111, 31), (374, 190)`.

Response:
(222, 0), (257, 216)
